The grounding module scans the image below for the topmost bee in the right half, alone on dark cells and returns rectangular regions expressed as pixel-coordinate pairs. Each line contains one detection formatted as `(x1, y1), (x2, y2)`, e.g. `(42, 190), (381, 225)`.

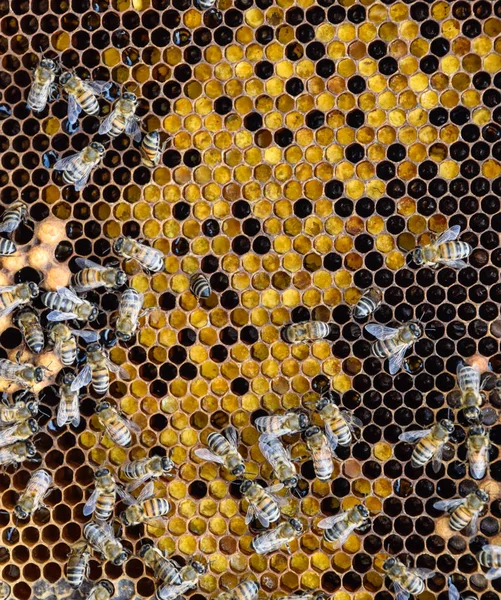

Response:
(412, 225), (473, 269)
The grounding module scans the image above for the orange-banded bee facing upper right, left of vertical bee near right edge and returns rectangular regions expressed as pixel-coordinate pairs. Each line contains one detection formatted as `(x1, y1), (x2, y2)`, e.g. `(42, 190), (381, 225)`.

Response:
(398, 419), (454, 473)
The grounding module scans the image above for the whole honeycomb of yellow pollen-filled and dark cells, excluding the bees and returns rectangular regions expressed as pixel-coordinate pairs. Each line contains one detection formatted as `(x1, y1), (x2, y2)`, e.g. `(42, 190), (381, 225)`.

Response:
(0, 0), (501, 600)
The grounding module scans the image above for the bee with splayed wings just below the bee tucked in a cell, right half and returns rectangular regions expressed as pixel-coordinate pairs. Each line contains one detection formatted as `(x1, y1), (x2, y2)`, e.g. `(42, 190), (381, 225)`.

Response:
(365, 321), (423, 375)
